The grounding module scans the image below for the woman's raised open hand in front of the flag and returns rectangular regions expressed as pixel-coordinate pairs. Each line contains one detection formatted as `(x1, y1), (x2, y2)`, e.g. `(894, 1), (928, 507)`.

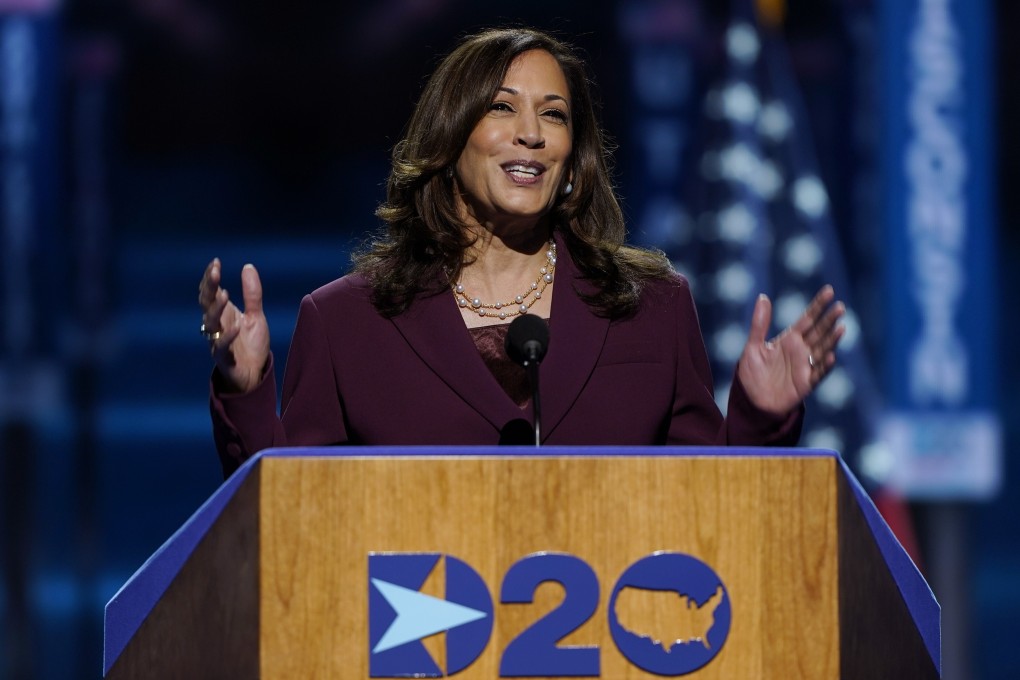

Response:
(737, 285), (847, 415)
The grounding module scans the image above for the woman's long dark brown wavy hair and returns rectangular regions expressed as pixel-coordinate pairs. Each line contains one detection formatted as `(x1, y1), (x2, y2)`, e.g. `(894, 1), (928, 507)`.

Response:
(354, 29), (671, 318)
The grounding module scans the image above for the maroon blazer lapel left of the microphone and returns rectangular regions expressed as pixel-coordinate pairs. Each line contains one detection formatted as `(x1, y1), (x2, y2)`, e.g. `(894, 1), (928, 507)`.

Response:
(385, 293), (521, 429)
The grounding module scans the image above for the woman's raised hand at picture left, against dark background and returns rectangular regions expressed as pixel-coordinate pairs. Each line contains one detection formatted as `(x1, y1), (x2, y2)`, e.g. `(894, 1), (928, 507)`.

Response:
(198, 258), (269, 393)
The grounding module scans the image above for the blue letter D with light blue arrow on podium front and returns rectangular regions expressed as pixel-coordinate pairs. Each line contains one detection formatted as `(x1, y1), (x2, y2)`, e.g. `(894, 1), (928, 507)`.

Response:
(368, 553), (493, 678)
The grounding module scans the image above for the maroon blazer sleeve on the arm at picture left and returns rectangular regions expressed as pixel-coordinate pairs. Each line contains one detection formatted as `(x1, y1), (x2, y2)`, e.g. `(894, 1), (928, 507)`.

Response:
(210, 296), (348, 475)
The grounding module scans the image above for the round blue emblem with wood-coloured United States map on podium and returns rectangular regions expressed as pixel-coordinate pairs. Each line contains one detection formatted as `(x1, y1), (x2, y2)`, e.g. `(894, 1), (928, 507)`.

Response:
(609, 553), (730, 676)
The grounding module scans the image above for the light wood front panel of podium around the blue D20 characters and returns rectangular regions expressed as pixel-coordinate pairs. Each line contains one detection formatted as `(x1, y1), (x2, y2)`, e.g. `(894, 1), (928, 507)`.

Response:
(260, 457), (839, 680)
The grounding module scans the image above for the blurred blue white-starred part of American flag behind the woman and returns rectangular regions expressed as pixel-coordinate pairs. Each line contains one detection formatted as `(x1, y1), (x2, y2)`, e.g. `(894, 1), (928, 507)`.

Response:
(642, 0), (901, 521)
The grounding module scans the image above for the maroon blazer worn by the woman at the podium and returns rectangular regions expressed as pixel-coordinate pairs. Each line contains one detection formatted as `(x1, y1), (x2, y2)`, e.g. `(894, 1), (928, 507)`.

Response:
(211, 244), (803, 473)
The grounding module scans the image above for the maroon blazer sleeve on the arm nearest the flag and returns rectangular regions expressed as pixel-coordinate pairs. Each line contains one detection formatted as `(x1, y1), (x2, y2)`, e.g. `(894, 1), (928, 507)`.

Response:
(666, 279), (804, 447)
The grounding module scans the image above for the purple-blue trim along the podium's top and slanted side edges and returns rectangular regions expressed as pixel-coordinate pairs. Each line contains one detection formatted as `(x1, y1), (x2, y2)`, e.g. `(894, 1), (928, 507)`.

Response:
(103, 447), (941, 676)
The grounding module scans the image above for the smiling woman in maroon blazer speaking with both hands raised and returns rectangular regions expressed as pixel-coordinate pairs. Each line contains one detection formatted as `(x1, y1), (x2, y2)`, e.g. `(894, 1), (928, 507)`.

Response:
(199, 25), (844, 473)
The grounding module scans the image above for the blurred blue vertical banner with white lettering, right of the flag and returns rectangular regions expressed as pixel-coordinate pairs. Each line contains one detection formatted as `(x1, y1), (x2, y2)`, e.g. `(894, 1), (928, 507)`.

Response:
(868, 0), (1002, 500)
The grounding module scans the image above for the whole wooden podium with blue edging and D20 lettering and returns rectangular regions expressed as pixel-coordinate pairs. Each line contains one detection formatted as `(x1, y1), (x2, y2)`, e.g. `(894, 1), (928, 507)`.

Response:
(104, 448), (940, 680)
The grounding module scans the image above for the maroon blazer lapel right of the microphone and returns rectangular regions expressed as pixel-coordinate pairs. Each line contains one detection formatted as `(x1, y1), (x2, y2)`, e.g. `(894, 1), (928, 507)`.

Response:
(539, 234), (609, 439)
